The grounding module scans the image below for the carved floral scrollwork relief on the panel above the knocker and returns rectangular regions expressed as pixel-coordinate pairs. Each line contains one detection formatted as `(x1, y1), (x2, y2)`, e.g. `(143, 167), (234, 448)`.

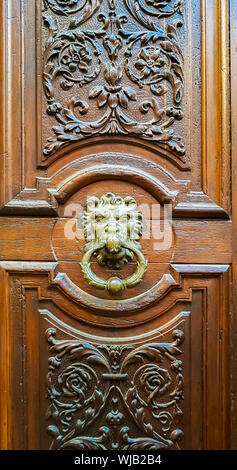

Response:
(43, 0), (185, 160)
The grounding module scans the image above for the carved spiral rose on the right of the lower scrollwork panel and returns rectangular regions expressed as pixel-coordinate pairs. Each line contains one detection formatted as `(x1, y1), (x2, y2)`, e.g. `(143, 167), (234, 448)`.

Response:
(140, 365), (171, 405)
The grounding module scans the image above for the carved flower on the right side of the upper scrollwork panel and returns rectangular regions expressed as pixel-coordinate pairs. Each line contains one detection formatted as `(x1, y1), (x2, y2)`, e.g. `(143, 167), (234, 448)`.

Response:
(135, 47), (165, 78)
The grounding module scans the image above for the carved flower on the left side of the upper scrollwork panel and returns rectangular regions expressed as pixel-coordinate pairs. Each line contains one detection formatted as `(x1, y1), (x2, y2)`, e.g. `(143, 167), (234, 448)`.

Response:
(62, 44), (92, 73)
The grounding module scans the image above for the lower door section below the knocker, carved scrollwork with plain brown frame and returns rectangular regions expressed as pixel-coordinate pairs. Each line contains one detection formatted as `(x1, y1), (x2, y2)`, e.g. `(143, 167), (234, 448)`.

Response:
(1, 262), (229, 450)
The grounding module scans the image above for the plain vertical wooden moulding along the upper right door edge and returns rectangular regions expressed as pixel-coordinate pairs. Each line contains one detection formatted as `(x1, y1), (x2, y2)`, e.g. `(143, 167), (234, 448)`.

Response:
(201, 0), (230, 212)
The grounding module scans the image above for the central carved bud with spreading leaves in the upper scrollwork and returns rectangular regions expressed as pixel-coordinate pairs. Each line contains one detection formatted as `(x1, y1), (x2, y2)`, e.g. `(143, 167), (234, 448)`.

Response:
(89, 64), (136, 109)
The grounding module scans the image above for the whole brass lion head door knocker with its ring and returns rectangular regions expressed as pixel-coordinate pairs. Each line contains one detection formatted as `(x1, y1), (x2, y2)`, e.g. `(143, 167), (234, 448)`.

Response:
(80, 193), (147, 294)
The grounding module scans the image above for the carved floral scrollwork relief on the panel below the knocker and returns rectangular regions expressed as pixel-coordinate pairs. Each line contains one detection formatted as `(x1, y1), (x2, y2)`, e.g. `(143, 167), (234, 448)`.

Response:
(46, 329), (184, 450)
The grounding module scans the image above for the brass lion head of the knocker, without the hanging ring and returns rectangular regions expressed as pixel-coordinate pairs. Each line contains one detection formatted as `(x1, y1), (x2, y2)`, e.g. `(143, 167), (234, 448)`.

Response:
(83, 193), (142, 269)
